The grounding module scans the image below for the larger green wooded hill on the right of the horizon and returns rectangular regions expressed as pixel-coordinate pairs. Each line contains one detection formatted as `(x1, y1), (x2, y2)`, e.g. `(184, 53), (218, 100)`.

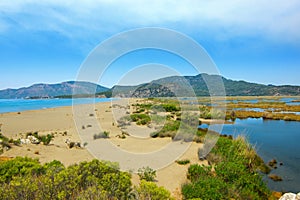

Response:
(106, 74), (300, 97)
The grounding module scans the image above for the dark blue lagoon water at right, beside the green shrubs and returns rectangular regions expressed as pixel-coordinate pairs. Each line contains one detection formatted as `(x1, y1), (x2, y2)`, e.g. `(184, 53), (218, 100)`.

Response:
(222, 118), (300, 193)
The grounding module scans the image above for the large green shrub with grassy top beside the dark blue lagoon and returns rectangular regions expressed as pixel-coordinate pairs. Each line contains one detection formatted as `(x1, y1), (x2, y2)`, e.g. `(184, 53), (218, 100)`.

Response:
(182, 137), (270, 199)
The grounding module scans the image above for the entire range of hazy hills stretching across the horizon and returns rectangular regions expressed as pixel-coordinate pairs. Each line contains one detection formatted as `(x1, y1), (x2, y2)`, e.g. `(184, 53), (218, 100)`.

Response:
(0, 74), (300, 99)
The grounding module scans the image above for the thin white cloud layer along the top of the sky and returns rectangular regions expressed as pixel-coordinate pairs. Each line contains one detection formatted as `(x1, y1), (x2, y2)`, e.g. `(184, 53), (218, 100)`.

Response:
(0, 0), (300, 42)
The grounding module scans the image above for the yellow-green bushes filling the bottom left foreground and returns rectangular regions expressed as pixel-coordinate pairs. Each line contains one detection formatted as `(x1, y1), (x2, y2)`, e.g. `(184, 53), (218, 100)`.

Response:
(0, 158), (132, 200)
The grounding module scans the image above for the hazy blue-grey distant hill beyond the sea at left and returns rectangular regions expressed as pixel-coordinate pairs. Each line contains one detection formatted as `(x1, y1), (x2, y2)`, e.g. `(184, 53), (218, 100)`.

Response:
(0, 81), (108, 99)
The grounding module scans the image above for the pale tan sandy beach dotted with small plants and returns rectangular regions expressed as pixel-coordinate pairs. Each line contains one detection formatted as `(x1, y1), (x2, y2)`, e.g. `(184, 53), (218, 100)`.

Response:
(0, 99), (205, 198)
